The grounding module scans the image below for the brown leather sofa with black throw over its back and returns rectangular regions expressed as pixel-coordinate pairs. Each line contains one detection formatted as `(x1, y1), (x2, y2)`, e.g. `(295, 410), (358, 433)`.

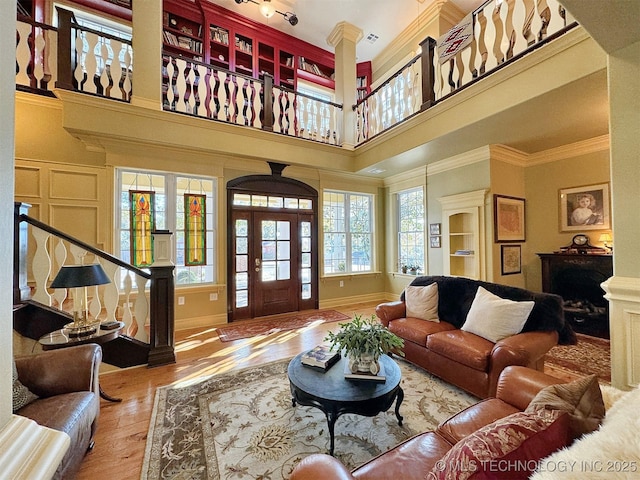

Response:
(376, 276), (576, 398)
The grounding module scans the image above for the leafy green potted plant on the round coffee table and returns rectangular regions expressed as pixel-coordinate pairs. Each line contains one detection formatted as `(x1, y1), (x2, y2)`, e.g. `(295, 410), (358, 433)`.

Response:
(325, 315), (404, 375)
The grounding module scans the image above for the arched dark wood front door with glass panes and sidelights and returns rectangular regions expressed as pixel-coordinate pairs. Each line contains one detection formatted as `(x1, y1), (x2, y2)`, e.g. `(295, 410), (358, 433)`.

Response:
(227, 162), (318, 321)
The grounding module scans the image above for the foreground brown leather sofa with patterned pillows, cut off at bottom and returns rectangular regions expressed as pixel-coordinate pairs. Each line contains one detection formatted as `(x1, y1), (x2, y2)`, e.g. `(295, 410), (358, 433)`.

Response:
(290, 366), (563, 480)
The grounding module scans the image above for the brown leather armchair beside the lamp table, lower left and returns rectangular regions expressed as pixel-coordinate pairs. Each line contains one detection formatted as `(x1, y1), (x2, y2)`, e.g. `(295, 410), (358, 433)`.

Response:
(15, 344), (102, 480)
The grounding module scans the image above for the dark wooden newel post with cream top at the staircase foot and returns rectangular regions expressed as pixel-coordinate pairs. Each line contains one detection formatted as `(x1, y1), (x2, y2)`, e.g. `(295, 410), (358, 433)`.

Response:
(147, 230), (176, 367)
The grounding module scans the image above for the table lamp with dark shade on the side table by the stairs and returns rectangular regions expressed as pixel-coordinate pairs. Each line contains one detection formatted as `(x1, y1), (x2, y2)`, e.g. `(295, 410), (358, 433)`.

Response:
(51, 263), (110, 336)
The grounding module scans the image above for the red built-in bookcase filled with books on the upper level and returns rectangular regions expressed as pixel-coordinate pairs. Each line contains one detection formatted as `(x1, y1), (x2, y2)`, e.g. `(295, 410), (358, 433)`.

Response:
(163, 0), (348, 89)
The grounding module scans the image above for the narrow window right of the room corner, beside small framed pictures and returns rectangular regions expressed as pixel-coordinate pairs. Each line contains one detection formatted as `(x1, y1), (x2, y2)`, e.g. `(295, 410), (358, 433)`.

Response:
(398, 187), (425, 271)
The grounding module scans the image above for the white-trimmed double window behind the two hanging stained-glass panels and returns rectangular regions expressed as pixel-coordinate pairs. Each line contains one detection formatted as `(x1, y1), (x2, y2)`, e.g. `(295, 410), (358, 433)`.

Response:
(115, 169), (217, 285)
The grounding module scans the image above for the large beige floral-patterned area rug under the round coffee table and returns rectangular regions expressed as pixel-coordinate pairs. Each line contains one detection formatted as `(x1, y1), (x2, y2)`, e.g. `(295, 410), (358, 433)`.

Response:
(141, 359), (478, 480)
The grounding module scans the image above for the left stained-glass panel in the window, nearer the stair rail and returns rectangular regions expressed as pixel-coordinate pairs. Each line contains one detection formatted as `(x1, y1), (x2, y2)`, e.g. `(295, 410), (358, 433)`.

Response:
(129, 190), (155, 267)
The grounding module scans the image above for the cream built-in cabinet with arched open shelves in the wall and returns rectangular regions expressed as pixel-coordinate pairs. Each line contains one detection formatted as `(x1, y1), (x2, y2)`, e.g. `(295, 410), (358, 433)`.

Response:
(438, 190), (487, 280)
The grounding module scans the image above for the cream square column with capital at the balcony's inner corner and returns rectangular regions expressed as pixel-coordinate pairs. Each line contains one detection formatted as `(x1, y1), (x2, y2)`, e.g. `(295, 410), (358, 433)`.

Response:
(327, 22), (362, 149)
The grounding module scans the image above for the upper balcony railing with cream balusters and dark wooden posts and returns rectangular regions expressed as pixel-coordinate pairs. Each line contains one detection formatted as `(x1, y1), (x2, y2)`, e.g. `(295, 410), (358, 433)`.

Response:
(16, 0), (576, 146)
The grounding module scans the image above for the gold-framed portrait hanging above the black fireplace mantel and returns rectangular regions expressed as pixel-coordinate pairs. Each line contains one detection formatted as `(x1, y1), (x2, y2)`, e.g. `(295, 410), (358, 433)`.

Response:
(559, 183), (611, 232)
